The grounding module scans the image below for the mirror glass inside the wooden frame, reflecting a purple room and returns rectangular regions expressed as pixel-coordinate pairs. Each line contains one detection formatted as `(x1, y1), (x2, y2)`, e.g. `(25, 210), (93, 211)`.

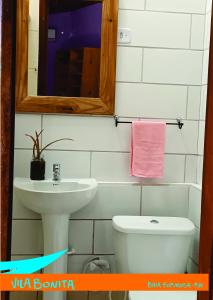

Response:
(28, 0), (102, 98)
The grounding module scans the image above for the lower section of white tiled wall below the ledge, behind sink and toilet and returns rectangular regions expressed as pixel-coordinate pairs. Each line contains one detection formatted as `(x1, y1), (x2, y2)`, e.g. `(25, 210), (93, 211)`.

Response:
(12, 183), (191, 262)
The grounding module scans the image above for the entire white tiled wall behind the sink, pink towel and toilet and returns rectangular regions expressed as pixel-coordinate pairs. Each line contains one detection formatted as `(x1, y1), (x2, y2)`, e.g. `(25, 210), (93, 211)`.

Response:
(13, 0), (211, 288)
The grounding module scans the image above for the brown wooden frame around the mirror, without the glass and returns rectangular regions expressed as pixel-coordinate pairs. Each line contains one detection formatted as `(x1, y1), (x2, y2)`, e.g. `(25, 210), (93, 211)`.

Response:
(16, 0), (118, 115)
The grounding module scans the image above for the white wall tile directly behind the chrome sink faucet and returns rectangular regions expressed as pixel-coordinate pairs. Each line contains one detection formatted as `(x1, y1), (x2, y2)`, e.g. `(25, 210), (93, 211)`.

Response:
(44, 151), (90, 178)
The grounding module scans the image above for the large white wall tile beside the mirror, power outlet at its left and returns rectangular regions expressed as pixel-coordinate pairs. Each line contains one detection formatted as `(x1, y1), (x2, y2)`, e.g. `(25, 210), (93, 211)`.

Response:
(119, 10), (191, 48)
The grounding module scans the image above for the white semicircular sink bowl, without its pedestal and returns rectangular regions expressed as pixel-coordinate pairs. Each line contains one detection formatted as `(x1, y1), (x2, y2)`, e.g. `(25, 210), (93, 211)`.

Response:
(14, 178), (97, 215)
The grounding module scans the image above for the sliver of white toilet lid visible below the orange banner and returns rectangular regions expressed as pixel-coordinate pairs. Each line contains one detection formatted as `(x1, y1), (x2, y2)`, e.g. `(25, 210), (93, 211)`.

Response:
(129, 291), (197, 300)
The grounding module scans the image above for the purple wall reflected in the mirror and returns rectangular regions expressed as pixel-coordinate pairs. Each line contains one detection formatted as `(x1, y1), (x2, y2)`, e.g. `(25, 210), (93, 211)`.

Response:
(47, 3), (102, 96)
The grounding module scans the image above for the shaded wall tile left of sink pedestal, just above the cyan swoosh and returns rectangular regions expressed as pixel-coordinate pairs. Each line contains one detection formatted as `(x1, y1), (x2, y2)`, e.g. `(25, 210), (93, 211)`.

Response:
(12, 220), (43, 255)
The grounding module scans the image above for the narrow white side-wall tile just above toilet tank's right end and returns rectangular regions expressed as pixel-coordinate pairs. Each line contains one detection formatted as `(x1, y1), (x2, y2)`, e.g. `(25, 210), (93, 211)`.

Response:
(189, 186), (201, 228)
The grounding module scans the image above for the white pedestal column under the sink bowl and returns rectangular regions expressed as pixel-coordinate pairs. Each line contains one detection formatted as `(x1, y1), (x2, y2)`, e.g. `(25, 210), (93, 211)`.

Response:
(42, 214), (69, 300)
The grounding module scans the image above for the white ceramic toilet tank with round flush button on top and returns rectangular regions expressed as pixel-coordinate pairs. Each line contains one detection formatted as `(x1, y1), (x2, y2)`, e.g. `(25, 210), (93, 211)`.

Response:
(112, 216), (195, 274)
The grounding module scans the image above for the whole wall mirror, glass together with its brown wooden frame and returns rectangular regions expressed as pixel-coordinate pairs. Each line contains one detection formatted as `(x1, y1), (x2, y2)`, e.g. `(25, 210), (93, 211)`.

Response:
(16, 0), (118, 115)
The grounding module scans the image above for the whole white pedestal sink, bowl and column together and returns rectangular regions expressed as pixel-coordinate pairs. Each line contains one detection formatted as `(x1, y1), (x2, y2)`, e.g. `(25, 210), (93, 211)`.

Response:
(14, 178), (98, 300)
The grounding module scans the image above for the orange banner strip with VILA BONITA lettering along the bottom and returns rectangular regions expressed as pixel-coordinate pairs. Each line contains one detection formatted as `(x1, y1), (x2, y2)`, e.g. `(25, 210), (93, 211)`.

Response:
(0, 274), (209, 292)
